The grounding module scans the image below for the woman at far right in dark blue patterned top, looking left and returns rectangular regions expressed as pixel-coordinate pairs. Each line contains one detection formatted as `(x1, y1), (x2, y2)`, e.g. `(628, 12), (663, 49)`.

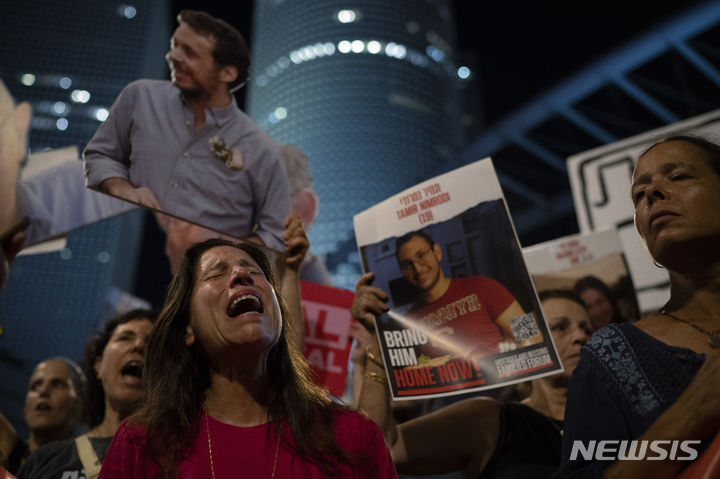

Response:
(557, 135), (720, 479)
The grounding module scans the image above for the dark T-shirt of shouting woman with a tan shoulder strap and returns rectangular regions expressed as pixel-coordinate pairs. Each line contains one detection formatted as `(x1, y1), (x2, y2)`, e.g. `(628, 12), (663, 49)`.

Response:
(17, 437), (112, 479)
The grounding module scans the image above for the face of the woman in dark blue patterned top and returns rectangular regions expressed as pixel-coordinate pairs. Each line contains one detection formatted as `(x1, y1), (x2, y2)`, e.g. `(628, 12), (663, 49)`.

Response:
(631, 140), (720, 264)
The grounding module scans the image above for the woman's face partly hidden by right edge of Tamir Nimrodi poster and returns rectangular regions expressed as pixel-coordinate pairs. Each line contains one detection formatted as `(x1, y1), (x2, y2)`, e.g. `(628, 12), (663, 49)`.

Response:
(542, 298), (592, 377)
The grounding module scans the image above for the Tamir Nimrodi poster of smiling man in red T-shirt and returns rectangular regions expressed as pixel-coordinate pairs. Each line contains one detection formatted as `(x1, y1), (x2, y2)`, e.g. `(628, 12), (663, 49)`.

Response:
(354, 159), (561, 399)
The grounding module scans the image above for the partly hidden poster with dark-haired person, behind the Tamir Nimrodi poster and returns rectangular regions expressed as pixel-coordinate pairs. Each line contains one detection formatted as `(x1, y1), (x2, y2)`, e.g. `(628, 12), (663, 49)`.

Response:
(523, 229), (640, 330)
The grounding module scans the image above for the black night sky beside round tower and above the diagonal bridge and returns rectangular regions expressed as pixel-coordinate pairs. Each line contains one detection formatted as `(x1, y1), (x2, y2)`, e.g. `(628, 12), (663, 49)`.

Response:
(172, 0), (704, 124)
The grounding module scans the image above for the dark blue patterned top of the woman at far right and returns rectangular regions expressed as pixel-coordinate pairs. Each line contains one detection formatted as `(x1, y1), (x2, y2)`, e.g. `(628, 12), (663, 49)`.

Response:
(553, 323), (705, 478)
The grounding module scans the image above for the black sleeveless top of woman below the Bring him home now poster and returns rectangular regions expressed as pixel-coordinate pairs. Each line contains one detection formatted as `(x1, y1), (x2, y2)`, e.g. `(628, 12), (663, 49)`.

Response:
(479, 402), (563, 479)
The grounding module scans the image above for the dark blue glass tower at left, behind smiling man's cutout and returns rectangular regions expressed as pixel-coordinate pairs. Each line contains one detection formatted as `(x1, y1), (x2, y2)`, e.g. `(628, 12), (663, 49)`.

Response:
(0, 0), (171, 437)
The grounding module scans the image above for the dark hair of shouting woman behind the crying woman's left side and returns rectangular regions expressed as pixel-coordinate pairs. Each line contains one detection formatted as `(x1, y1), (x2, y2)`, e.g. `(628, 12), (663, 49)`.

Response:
(80, 309), (157, 429)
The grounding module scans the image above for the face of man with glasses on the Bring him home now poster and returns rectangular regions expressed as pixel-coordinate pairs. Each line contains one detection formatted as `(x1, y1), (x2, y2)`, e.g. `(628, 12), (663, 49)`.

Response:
(397, 236), (442, 291)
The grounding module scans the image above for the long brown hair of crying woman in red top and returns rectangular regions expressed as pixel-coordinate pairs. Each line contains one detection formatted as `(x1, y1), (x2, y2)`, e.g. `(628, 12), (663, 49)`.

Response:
(135, 238), (368, 475)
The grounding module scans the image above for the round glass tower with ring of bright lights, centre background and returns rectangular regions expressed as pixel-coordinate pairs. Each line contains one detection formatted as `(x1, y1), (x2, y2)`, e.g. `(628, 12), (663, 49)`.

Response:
(246, 0), (462, 288)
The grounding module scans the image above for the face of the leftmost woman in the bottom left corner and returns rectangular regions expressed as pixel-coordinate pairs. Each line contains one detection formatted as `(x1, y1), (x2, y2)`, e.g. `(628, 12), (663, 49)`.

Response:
(23, 359), (79, 431)
